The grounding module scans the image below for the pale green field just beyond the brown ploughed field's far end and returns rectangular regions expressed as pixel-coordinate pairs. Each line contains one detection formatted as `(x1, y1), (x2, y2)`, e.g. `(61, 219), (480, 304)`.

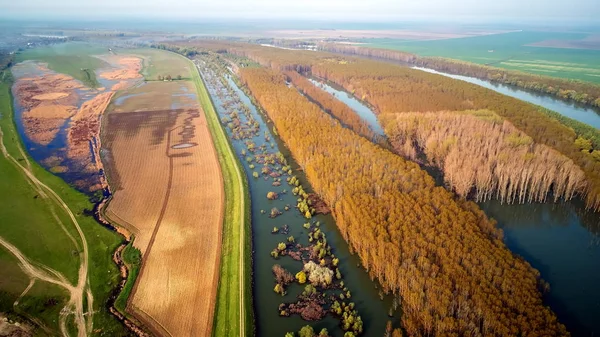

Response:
(125, 49), (192, 81)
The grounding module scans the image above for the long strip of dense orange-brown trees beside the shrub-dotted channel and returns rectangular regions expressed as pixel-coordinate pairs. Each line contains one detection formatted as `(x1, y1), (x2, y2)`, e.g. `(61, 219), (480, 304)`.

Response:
(240, 68), (568, 336)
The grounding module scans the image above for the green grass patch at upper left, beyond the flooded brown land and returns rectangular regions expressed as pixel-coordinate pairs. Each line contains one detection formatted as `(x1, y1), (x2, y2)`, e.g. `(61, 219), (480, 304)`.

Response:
(15, 42), (108, 88)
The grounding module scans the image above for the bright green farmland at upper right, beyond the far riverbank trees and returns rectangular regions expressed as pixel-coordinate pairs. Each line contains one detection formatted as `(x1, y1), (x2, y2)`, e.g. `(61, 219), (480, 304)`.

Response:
(362, 32), (600, 83)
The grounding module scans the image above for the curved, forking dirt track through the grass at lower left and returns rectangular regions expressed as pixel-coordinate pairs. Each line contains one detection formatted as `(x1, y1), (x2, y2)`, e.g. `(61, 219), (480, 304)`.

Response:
(0, 128), (93, 337)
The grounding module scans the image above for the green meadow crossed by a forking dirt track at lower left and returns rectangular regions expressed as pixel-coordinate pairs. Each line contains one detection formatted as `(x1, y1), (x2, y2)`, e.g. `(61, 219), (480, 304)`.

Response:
(0, 73), (128, 336)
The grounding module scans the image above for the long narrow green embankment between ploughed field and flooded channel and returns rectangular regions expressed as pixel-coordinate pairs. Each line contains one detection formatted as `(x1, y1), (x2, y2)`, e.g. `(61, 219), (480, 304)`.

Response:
(181, 51), (254, 336)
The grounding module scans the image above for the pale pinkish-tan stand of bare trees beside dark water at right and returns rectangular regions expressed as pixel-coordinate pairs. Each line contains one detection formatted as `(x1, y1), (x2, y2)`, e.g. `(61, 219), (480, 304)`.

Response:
(380, 110), (585, 203)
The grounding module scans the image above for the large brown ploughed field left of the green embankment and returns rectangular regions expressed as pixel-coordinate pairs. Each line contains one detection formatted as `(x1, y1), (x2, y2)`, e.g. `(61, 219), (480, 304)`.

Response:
(102, 100), (224, 336)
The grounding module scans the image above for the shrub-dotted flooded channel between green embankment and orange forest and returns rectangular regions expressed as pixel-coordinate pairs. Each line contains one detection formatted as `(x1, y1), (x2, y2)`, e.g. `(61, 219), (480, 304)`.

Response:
(199, 59), (400, 337)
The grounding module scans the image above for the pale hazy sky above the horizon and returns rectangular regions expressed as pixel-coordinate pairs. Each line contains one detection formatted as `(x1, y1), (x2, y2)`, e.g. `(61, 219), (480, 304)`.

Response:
(0, 0), (600, 23)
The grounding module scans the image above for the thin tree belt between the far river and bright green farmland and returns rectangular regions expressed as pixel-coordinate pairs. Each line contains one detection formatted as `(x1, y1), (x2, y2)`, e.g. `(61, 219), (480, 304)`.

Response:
(319, 43), (600, 107)
